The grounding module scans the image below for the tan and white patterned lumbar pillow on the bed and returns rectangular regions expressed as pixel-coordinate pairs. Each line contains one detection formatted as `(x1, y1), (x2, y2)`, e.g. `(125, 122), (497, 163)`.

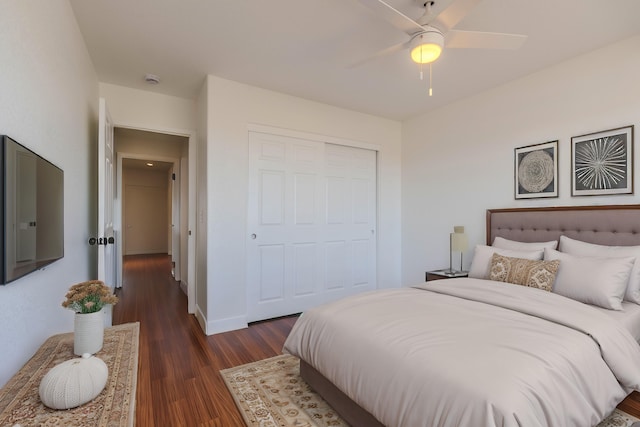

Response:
(489, 254), (560, 292)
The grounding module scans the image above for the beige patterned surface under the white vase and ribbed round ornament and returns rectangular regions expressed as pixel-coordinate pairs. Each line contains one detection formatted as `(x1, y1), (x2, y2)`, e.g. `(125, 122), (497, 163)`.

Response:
(0, 322), (140, 427)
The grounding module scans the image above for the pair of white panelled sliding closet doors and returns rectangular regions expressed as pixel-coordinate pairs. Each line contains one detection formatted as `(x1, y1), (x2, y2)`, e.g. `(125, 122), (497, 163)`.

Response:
(247, 132), (376, 321)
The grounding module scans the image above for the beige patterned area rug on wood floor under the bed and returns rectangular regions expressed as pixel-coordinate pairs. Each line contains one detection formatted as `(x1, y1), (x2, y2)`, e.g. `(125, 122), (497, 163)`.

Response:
(220, 355), (640, 427)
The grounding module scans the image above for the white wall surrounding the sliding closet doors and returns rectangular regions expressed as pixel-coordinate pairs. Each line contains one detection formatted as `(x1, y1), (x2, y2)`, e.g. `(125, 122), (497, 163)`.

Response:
(204, 76), (401, 334)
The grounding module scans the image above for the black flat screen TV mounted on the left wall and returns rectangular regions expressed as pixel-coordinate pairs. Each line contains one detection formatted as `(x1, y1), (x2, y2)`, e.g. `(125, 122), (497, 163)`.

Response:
(0, 135), (64, 285)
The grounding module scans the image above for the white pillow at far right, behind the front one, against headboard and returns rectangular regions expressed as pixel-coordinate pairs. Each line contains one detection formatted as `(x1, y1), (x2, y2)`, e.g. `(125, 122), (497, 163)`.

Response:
(559, 236), (640, 304)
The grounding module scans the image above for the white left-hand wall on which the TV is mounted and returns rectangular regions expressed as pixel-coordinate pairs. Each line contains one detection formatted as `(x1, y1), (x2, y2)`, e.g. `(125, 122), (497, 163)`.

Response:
(0, 0), (98, 385)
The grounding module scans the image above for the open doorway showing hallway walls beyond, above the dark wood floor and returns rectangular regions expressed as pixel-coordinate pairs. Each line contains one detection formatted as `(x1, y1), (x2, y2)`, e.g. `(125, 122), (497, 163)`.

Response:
(114, 127), (193, 300)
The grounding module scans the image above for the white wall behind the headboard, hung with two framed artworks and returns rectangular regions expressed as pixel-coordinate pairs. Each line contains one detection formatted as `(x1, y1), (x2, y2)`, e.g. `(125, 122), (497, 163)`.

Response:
(402, 37), (640, 285)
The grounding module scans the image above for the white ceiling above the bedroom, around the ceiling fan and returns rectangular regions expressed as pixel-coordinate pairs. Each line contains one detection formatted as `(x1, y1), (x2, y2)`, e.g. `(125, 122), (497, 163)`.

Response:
(70, 0), (640, 120)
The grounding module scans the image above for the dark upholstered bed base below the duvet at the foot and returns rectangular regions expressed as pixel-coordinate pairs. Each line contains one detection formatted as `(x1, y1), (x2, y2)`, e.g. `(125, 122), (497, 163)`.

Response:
(300, 360), (385, 427)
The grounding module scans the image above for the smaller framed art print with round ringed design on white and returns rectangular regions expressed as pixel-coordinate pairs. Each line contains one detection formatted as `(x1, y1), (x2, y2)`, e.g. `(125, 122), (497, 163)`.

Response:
(514, 141), (558, 199)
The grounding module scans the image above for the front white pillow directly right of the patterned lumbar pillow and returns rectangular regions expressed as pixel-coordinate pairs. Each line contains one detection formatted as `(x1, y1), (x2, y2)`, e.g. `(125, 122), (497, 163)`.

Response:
(544, 248), (635, 310)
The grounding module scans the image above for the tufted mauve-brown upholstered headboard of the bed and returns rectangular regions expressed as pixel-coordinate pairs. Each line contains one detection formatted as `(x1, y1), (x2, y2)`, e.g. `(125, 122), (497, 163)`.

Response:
(487, 205), (640, 246)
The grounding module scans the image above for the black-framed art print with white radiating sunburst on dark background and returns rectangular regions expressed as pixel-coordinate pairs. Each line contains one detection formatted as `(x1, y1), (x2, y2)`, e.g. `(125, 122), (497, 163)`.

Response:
(571, 125), (633, 196)
